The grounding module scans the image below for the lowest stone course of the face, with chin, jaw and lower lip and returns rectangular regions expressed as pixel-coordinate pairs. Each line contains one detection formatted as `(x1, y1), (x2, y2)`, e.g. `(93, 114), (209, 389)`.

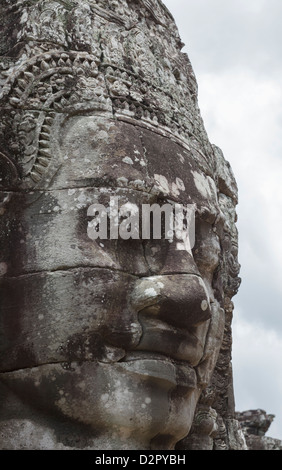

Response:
(1, 358), (202, 450)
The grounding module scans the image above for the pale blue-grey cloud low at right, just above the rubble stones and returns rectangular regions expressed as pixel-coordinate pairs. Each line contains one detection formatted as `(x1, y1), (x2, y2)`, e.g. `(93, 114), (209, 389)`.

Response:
(233, 310), (282, 439)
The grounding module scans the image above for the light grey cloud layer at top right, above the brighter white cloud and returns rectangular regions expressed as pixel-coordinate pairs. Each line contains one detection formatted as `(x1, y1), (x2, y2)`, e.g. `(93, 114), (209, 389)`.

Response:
(164, 0), (282, 75)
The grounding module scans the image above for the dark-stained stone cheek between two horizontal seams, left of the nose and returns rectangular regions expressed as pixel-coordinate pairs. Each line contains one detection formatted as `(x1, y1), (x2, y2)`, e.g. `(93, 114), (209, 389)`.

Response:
(0, 268), (141, 370)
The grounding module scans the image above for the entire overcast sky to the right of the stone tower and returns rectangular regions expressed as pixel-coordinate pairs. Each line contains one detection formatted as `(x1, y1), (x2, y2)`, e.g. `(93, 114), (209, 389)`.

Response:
(163, 0), (282, 439)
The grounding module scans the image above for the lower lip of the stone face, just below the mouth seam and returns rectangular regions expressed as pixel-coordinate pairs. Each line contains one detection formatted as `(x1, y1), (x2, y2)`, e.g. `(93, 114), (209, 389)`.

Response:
(119, 351), (197, 390)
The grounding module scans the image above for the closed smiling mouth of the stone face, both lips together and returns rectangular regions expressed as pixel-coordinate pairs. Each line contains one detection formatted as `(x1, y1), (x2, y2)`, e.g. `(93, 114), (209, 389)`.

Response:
(115, 312), (204, 393)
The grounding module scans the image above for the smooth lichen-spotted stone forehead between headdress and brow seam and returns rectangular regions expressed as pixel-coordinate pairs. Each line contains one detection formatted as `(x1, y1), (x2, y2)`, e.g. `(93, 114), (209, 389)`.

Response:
(57, 115), (217, 212)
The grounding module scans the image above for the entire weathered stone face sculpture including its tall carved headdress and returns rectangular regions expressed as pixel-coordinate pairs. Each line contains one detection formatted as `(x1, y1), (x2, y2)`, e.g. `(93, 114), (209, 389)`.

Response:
(0, 0), (244, 449)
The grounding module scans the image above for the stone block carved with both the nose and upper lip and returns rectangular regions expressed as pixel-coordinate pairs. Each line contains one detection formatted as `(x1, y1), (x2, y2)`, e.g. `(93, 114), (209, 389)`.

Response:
(129, 274), (211, 366)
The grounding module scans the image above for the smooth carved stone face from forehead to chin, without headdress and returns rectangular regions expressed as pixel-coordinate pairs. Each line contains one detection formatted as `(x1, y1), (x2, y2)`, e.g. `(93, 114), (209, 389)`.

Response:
(2, 115), (224, 448)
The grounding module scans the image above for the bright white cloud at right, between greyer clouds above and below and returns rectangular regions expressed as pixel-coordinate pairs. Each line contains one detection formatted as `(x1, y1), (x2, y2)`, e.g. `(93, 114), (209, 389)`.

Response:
(199, 71), (282, 334)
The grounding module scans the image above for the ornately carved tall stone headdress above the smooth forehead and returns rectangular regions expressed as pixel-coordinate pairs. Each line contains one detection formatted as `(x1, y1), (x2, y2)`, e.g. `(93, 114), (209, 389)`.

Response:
(0, 0), (213, 191)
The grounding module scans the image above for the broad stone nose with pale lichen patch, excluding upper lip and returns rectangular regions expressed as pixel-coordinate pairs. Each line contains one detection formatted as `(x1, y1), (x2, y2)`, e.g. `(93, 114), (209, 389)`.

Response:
(132, 274), (211, 330)
